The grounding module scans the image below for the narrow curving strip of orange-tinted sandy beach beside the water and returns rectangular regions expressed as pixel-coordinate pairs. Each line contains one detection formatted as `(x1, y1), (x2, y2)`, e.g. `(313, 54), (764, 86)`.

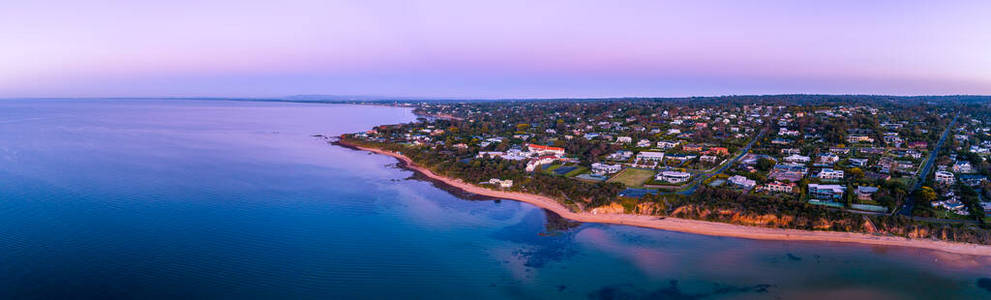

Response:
(338, 142), (991, 257)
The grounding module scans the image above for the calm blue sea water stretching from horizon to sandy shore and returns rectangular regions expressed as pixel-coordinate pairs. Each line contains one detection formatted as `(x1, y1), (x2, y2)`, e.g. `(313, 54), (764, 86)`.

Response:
(0, 100), (991, 299)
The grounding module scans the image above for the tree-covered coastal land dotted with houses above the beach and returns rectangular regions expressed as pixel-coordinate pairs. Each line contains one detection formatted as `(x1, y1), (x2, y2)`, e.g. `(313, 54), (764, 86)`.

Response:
(340, 95), (991, 244)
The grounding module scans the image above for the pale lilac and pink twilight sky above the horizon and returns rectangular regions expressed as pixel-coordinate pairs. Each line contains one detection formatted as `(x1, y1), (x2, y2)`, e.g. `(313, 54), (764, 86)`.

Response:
(0, 0), (991, 98)
